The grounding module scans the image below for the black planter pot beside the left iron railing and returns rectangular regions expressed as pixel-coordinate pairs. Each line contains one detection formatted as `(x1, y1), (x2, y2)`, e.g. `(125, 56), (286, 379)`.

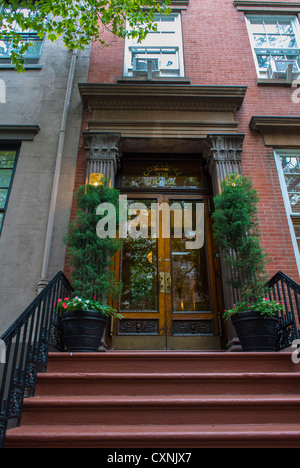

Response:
(62, 310), (108, 353)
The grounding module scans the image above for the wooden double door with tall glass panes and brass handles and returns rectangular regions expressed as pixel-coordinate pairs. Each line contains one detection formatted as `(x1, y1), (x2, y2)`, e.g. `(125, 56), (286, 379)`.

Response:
(111, 193), (222, 350)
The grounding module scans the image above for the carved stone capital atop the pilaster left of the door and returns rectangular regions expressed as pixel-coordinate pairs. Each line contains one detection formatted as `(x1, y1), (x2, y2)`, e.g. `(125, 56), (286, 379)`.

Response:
(84, 132), (121, 187)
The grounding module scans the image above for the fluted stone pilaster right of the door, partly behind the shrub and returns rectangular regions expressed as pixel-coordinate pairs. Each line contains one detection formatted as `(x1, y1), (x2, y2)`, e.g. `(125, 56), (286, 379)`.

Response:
(208, 134), (245, 351)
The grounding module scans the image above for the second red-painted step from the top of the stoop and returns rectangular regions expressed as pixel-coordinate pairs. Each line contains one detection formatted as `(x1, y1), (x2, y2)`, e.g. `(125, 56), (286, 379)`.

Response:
(36, 372), (300, 396)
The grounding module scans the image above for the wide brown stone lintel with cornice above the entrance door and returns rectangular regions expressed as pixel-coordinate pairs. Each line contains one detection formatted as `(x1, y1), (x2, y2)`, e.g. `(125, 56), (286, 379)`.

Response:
(79, 83), (247, 140)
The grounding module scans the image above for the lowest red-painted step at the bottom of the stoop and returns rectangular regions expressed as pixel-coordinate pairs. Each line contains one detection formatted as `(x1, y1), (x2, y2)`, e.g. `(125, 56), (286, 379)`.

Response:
(7, 424), (300, 449)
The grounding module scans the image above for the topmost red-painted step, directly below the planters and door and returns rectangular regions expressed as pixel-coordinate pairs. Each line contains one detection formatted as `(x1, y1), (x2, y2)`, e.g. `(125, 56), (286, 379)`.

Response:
(48, 351), (300, 374)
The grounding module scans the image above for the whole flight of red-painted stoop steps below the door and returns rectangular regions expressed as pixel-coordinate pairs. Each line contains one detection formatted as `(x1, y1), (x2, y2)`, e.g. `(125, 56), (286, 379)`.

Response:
(6, 351), (300, 448)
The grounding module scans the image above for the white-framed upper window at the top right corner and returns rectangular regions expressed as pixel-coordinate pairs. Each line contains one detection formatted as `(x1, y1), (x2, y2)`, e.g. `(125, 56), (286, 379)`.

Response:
(246, 15), (300, 79)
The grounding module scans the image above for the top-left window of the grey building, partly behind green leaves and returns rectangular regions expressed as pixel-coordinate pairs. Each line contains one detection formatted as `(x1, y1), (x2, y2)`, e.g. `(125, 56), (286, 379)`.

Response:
(0, 9), (43, 65)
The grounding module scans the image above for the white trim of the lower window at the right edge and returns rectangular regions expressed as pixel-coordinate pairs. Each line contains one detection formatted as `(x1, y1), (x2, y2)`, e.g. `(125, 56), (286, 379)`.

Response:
(274, 150), (300, 275)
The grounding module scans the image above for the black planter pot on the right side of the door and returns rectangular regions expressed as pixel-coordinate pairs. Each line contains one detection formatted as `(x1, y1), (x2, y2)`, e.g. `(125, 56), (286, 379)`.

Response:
(231, 311), (279, 352)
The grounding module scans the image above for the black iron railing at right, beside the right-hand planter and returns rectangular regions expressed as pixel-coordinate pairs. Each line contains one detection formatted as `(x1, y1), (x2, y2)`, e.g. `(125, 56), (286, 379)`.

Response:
(268, 271), (300, 351)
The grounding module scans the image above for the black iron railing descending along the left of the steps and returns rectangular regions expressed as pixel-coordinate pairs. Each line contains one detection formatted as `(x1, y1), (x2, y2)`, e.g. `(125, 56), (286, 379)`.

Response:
(0, 272), (73, 448)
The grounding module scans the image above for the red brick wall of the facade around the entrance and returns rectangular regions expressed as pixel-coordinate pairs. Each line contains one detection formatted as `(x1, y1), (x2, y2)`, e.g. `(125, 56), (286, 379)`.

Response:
(67, 0), (300, 281)
